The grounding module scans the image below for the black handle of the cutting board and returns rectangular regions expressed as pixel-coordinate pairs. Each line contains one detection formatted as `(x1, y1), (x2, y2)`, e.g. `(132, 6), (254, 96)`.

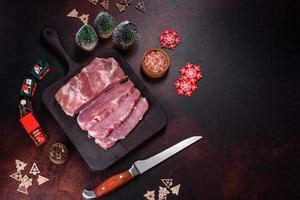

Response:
(42, 27), (74, 71)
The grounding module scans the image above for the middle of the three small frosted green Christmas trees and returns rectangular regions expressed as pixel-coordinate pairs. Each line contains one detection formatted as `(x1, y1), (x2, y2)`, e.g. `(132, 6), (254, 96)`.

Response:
(94, 11), (116, 38)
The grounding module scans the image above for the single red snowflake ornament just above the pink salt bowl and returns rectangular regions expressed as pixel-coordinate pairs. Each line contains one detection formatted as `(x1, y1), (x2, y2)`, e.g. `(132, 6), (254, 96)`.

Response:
(159, 29), (181, 50)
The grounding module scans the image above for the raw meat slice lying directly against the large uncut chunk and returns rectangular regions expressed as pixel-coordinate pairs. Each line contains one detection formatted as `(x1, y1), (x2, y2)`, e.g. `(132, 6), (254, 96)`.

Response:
(77, 81), (134, 130)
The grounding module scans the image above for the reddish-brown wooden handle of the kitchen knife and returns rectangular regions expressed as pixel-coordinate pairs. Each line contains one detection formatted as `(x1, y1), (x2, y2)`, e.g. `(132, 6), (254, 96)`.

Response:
(94, 171), (133, 197)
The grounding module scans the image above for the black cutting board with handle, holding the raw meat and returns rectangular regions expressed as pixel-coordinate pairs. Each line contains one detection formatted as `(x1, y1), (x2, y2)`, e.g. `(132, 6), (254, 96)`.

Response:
(42, 27), (167, 170)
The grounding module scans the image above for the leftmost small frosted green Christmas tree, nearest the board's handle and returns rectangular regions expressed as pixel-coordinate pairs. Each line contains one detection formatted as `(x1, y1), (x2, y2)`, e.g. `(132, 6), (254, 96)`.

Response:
(76, 24), (98, 51)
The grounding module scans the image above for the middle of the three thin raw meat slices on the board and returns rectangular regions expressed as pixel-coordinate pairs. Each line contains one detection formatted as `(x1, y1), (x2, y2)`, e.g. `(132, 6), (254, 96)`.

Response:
(88, 89), (140, 139)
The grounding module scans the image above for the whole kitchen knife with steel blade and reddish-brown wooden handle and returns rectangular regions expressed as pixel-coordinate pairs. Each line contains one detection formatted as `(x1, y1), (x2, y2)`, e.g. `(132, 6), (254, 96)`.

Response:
(82, 136), (202, 199)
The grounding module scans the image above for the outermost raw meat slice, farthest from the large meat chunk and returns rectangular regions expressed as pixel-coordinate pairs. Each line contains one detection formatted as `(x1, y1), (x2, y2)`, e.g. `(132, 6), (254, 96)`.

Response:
(95, 98), (149, 149)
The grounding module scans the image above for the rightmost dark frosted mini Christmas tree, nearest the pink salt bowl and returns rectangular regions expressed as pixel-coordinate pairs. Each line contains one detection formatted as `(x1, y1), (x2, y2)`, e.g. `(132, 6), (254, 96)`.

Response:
(113, 21), (141, 49)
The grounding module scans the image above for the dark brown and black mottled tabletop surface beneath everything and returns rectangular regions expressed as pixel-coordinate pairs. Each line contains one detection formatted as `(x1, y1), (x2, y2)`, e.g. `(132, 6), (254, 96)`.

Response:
(0, 0), (300, 200)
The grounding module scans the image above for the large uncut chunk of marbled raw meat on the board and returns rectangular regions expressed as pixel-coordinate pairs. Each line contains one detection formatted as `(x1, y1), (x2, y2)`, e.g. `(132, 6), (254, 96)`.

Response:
(55, 58), (126, 116)
